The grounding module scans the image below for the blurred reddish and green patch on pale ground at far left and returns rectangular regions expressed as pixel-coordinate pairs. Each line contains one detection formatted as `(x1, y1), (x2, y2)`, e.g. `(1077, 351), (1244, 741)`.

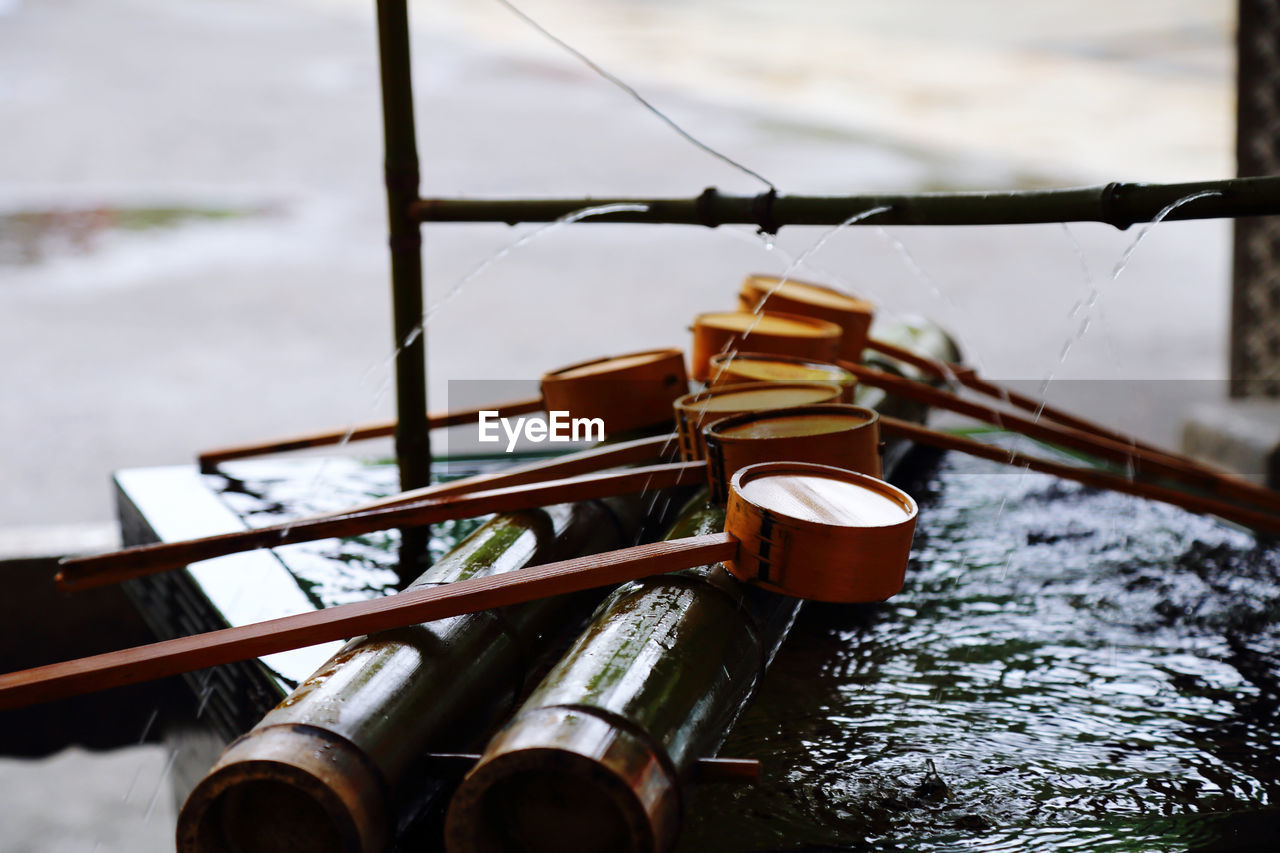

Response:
(0, 206), (273, 266)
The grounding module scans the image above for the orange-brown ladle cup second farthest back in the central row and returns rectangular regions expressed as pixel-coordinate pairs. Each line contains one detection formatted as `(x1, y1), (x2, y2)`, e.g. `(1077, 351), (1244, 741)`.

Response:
(691, 311), (842, 382)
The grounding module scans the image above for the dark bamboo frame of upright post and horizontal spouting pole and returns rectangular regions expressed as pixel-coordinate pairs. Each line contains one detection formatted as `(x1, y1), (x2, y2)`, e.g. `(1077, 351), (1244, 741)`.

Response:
(378, 0), (1280, 560)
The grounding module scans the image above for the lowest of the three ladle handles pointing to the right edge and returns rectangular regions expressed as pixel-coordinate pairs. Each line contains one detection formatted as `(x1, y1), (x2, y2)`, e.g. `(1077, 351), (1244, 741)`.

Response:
(879, 415), (1280, 535)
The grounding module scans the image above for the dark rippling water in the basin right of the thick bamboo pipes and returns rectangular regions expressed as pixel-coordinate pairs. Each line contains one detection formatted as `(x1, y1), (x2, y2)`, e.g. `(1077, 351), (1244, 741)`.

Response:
(681, 455), (1280, 850)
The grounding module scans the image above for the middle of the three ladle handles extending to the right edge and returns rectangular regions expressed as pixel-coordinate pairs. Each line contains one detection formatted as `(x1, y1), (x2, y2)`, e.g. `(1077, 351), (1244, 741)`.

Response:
(838, 361), (1280, 514)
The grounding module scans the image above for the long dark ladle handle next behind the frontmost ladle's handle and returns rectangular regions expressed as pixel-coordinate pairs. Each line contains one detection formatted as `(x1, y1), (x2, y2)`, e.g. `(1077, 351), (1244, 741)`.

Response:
(56, 461), (707, 590)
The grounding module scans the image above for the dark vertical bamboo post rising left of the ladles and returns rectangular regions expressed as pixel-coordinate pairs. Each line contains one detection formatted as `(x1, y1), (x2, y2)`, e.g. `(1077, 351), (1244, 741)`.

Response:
(378, 0), (431, 578)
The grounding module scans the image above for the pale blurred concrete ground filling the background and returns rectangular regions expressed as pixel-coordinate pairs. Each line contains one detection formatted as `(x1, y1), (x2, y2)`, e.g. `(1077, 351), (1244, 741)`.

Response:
(0, 0), (1234, 850)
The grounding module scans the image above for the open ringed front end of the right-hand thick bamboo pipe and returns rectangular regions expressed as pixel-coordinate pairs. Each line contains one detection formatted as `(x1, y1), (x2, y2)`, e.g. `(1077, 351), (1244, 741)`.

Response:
(445, 707), (681, 853)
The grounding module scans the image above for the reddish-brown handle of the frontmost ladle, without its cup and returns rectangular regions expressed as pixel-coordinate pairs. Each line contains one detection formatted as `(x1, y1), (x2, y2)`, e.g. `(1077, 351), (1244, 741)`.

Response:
(0, 533), (737, 711)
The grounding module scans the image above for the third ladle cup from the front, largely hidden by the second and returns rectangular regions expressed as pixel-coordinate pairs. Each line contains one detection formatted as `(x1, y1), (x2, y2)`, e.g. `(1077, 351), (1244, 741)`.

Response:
(675, 382), (842, 461)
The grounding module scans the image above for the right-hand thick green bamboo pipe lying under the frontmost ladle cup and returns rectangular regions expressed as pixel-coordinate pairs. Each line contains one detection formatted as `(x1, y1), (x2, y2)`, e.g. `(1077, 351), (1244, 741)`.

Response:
(445, 318), (956, 853)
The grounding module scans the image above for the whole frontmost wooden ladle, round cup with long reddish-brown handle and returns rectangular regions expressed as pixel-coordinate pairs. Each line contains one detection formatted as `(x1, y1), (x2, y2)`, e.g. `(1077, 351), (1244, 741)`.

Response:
(0, 462), (918, 710)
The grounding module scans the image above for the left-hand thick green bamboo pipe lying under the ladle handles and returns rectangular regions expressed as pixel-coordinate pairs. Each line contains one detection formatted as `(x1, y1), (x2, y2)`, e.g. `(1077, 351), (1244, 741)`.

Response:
(177, 484), (686, 853)
